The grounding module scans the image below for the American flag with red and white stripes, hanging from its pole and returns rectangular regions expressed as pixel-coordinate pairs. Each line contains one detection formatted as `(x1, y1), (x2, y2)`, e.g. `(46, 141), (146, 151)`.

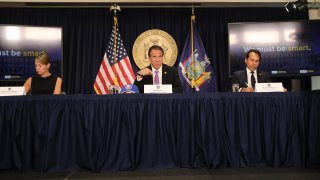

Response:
(94, 23), (135, 94)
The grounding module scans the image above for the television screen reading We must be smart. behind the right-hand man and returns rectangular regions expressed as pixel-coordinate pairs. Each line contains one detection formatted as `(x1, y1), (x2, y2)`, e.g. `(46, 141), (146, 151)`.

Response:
(228, 20), (320, 76)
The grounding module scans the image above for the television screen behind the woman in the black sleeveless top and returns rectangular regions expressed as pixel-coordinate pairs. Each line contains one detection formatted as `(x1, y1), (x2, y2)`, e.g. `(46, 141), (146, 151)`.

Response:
(0, 25), (62, 81)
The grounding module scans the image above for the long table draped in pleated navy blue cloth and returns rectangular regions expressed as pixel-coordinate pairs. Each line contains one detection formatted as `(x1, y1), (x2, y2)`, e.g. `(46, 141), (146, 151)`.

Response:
(0, 91), (320, 172)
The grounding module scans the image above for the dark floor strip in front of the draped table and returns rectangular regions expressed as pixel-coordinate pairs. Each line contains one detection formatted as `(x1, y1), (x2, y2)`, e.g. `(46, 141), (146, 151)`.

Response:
(0, 168), (320, 180)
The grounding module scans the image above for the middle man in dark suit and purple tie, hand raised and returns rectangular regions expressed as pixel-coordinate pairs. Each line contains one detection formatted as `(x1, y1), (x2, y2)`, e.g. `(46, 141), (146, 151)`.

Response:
(134, 45), (182, 93)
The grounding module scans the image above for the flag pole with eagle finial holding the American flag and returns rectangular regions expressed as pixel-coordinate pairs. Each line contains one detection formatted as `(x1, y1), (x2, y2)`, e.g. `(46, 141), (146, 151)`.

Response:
(110, 4), (121, 86)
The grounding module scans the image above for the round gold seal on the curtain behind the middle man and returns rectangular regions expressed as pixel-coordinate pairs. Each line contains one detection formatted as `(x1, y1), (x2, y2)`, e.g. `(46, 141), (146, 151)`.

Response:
(132, 29), (178, 69)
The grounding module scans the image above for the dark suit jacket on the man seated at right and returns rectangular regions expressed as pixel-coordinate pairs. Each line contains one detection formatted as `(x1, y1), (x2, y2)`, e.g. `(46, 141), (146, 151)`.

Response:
(232, 69), (270, 88)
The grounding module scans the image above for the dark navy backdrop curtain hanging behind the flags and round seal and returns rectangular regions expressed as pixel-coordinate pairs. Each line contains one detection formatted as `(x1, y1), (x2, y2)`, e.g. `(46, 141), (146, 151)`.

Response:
(0, 8), (308, 94)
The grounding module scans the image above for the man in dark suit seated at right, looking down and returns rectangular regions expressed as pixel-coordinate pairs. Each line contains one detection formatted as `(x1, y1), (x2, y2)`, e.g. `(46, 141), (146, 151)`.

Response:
(232, 49), (270, 92)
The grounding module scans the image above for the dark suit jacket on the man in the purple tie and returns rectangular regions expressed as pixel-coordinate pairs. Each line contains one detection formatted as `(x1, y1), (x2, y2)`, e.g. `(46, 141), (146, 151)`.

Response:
(134, 64), (182, 93)
